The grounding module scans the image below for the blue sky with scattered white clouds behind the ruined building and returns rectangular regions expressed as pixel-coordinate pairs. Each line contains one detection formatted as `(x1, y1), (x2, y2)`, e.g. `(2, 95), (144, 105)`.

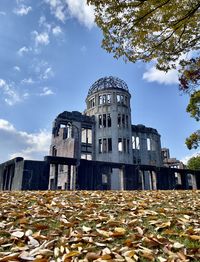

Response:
(0, 0), (199, 163)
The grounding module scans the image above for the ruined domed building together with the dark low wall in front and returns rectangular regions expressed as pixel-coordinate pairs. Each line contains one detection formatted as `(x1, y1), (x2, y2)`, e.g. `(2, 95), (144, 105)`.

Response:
(0, 76), (200, 190)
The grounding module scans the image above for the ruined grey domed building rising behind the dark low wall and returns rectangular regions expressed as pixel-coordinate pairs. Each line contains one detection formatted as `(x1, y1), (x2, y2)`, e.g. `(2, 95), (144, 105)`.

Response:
(50, 76), (163, 189)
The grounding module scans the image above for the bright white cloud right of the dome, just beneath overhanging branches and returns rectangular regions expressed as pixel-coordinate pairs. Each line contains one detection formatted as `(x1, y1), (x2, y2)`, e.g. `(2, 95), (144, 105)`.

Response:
(143, 66), (178, 85)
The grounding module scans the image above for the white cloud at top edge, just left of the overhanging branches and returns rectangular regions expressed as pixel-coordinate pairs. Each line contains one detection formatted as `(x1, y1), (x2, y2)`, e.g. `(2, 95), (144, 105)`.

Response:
(44, 0), (94, 28)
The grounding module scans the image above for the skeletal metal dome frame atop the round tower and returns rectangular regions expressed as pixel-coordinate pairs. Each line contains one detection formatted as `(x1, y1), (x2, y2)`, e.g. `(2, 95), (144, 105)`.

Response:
(88, 76), (129, 96)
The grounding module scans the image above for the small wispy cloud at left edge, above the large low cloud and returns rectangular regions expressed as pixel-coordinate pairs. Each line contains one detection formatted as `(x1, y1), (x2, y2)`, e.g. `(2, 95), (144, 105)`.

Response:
(0, 79), (21, 106)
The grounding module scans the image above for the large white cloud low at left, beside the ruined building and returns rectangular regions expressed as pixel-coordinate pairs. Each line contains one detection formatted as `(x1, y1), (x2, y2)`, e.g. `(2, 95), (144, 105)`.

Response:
(0, 119), (51, 161)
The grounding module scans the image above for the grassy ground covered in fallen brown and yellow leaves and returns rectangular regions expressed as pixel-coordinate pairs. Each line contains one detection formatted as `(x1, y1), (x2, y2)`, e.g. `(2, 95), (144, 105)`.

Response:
(0, 191), (200, 262)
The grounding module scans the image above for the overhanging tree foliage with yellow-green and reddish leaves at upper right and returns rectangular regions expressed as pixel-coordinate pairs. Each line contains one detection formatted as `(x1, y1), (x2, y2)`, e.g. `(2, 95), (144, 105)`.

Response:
(87, 0), (200, 149)
